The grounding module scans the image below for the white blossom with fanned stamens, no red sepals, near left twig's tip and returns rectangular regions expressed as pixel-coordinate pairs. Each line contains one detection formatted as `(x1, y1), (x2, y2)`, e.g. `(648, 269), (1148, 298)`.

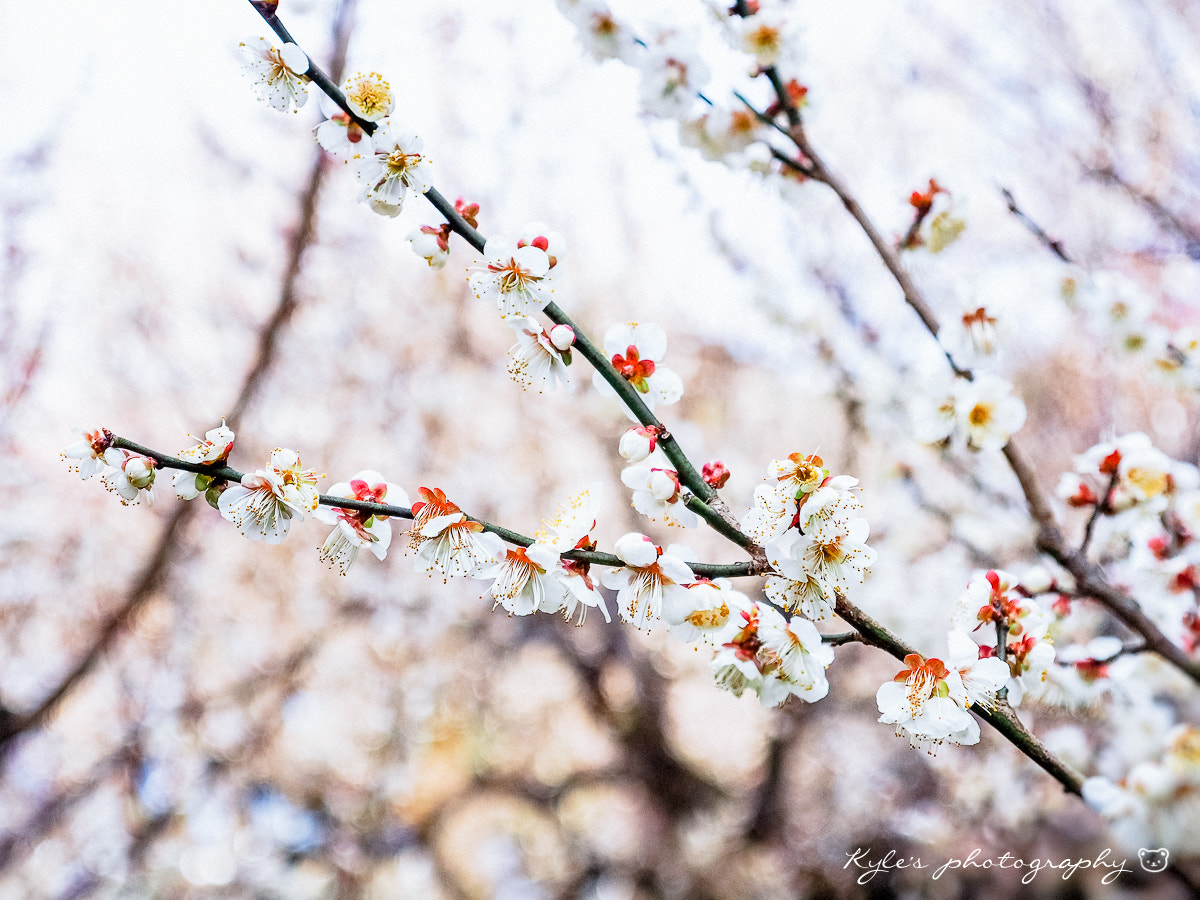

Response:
(217, 448), (318, 544)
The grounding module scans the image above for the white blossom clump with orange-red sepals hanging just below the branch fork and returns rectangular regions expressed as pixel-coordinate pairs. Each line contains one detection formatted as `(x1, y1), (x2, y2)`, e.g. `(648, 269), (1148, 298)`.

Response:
(712, 602), (834, 707)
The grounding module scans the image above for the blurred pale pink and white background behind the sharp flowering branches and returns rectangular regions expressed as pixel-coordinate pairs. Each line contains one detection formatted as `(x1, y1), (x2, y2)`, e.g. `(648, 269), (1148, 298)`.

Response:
(0, 0), (1200, 900)
